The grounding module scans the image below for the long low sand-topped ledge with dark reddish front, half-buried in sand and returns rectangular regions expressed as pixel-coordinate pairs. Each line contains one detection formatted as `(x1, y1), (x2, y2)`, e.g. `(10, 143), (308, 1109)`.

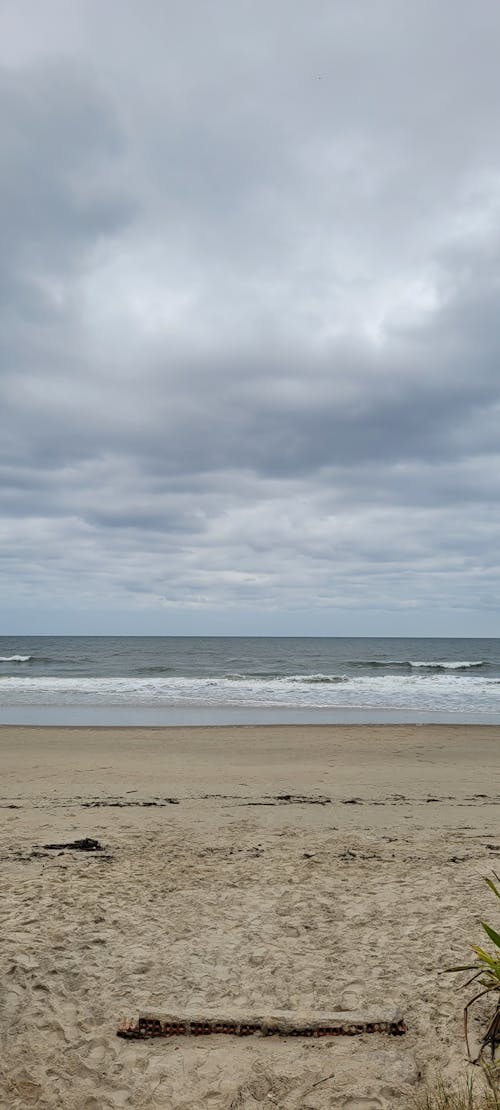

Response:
(118, 1010), (407, 1040)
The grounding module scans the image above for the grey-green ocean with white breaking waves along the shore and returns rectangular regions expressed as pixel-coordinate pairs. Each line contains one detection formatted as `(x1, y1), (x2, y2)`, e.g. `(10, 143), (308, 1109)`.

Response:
(0, 636), (500, 725)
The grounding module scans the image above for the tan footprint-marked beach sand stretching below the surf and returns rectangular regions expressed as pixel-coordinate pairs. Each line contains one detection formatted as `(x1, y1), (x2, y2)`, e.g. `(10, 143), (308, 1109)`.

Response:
(0, 725), (500, 1110)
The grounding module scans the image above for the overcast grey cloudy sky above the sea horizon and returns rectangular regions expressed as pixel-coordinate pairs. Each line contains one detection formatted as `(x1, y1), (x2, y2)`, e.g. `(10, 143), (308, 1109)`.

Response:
(0, 0), (500, 636)
